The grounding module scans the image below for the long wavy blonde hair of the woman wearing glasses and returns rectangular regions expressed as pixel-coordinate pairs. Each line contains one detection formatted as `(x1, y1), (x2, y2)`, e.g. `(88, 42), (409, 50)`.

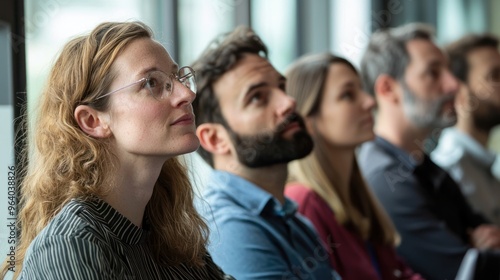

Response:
(1, 22), (208, 277)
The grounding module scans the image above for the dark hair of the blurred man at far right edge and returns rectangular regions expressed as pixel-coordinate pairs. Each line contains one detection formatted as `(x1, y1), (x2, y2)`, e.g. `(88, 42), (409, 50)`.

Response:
(445, 34), (498, 83)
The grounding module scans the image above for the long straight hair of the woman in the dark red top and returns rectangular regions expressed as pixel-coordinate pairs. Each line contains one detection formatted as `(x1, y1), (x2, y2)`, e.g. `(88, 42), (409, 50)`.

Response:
(286, 53), (399, 245)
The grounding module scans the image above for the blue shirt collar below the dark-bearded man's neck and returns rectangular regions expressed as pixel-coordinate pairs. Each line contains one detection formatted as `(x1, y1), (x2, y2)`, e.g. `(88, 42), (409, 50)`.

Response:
(209, 170), (298, 218)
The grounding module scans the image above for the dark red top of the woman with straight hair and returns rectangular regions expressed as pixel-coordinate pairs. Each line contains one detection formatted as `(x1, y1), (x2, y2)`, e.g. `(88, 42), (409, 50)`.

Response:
(285, 183), (423, 280)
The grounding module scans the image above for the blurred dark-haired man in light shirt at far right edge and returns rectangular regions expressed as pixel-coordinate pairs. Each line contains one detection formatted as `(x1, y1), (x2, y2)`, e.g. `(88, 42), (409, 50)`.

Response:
(431, 34), (500, 226)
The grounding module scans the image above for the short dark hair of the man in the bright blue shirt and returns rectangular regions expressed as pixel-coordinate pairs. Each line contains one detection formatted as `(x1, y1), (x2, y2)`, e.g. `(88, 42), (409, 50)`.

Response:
(193, 26), (267, 167)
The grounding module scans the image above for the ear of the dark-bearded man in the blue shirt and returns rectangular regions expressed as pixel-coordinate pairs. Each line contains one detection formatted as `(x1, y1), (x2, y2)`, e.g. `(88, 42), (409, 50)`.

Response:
(196, 123), (231, 154)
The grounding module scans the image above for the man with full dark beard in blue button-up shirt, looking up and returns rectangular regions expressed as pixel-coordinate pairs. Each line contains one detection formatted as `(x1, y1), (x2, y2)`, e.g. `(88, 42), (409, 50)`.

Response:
(193, 27), (338, 279)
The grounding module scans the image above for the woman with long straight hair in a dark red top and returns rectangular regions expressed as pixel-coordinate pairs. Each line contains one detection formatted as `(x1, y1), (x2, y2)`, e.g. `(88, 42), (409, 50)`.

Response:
(285, 53), (421, 280)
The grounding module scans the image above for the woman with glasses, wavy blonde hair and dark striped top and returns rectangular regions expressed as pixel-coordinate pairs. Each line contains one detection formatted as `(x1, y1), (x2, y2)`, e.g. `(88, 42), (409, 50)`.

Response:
(3, 22), (231, 279)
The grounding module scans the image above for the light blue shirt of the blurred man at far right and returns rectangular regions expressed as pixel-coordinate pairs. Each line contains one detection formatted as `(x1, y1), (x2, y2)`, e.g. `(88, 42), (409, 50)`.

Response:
(431, 127), (500, 226)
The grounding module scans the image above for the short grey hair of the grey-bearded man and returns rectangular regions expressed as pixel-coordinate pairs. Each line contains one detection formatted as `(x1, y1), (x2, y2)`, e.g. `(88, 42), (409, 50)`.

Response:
(361, 23), (434, 95)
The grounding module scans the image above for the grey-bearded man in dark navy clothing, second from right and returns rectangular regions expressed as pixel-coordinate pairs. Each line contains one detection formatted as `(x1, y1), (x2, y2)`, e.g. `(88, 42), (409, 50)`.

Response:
(359, 23), (500, 279)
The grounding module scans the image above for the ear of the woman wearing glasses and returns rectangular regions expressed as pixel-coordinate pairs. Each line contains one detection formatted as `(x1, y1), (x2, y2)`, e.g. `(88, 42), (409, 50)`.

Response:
(74, 105), (111, 138)
